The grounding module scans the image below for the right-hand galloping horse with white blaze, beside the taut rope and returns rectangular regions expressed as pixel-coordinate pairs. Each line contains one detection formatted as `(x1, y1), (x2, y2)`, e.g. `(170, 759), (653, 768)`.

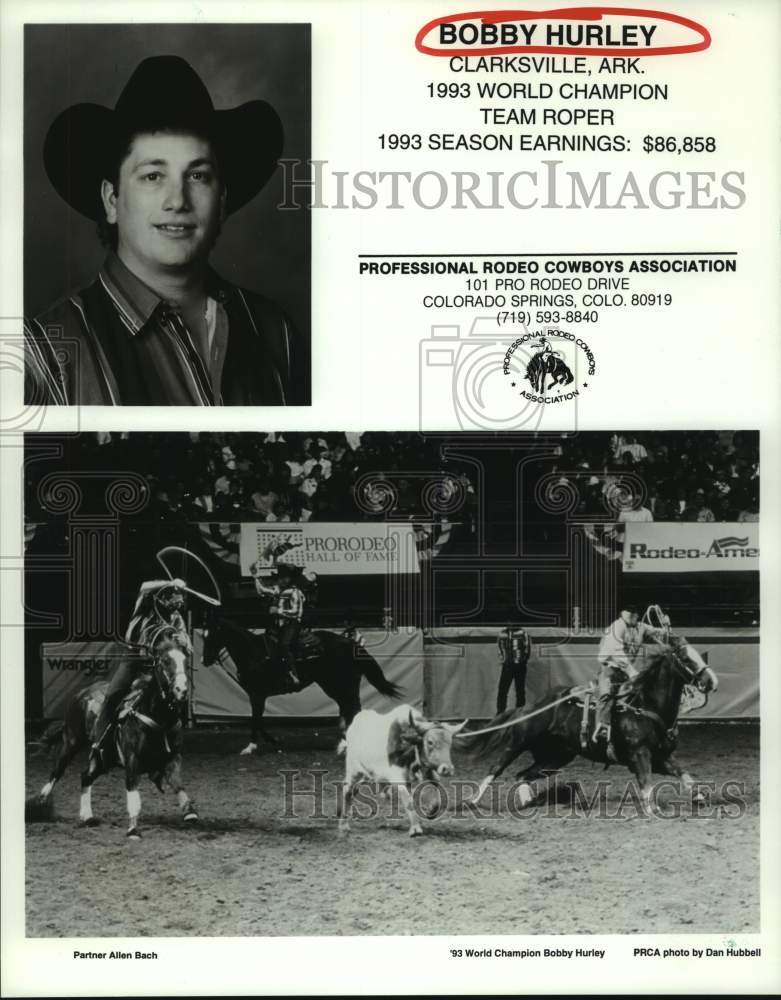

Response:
(463, 636), (718, 811)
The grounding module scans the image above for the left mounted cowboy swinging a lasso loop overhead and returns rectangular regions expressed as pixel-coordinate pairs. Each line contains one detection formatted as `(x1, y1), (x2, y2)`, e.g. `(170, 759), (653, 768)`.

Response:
(90, 577), (192, 759)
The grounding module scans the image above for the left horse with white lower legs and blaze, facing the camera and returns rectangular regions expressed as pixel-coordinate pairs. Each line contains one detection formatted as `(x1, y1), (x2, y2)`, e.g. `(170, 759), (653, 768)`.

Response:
(29, 625), (198, 840)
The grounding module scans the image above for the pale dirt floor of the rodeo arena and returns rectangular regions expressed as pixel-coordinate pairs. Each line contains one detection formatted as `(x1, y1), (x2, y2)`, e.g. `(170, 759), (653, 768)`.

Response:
(26, 724), (759, 937)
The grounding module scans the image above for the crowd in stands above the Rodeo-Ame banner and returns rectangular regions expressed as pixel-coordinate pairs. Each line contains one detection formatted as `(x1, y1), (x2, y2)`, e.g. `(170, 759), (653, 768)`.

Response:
(554, 431), (759, 522)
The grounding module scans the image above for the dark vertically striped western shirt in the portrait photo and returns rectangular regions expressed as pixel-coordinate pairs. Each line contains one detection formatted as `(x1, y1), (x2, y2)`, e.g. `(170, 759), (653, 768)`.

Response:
(25, 253), (298, 406)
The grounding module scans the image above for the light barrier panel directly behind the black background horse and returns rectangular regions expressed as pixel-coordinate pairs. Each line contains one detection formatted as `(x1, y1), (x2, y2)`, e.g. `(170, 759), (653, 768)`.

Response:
(193, 629), (423, 718)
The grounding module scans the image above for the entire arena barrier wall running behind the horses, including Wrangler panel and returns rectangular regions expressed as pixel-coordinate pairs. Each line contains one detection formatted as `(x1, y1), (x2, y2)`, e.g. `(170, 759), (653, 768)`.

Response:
(42, 628), (759, 719)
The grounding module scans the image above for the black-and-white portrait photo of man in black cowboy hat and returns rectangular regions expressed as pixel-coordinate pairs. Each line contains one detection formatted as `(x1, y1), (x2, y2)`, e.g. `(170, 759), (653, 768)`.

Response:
(24, 24), (311, 406)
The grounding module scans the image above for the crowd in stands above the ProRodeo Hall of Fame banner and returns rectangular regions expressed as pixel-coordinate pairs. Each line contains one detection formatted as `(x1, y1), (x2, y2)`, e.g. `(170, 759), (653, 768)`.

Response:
(27, 432), (474, 522)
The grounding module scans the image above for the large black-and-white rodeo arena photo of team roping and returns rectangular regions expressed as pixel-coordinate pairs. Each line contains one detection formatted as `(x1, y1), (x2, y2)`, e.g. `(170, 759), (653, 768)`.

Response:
(24, 430), (760, 937)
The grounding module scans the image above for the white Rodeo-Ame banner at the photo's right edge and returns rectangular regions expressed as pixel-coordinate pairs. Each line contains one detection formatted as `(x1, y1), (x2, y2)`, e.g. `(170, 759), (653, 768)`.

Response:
(623, 521), (759, 573)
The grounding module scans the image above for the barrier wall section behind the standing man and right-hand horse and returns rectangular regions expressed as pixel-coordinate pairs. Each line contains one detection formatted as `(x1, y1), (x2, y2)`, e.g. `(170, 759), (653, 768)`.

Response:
(424, 628), (759, 719)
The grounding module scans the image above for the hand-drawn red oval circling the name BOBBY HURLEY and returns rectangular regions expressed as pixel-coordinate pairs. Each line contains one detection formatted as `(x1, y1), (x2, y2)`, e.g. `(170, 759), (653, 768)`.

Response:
(415, 7), (711, 56)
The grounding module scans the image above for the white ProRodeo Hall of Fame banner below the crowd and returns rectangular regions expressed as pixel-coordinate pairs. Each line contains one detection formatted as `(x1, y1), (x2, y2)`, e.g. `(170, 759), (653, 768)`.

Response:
(239, 522), (420, 576)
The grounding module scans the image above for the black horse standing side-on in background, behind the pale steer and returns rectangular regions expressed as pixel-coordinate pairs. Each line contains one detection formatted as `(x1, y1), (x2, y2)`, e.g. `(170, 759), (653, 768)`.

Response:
(203, 618), (401, 754)
